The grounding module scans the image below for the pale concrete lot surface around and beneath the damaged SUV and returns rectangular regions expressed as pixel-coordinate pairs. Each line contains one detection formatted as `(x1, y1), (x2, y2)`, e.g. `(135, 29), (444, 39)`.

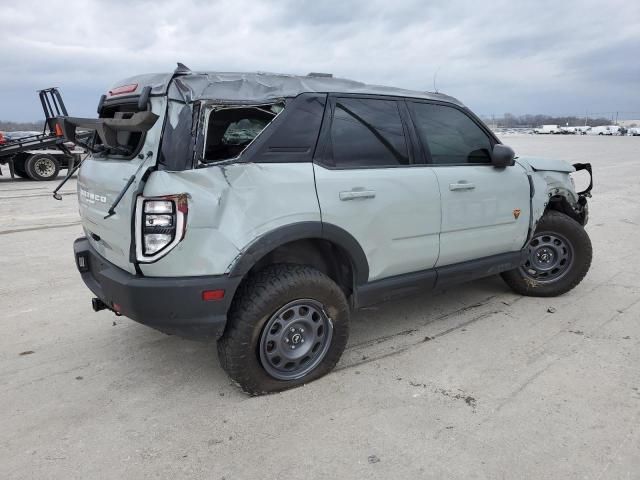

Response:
(0, 136), (640, 480)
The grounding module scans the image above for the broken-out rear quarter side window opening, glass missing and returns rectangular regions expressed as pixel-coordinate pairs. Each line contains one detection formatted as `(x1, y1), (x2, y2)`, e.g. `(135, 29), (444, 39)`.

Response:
(204, 103), (284, 163)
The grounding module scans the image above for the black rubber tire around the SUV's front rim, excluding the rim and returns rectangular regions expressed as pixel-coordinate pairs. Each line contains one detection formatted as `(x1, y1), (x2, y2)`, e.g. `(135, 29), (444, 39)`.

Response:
(502, 210), (593, 297)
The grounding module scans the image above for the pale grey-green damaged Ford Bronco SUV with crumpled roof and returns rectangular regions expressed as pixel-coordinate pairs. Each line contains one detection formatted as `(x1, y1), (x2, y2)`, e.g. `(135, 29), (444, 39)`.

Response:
(59, 65), (592, 394)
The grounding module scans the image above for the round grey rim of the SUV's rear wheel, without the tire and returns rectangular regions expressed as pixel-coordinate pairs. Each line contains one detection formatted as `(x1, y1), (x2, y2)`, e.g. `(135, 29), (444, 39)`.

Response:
(258, 299), (333, 380)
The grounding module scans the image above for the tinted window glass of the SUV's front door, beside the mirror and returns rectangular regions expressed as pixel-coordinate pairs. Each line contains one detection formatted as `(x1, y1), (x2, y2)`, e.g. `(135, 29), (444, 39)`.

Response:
(409, 102), (493, 165)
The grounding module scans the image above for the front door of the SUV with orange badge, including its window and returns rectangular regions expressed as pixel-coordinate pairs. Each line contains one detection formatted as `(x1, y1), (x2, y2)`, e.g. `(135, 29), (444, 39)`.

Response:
(407, 101), (530, 266)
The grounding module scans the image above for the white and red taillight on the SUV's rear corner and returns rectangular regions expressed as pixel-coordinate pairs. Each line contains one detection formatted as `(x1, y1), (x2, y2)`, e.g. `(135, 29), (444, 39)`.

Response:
(136, 194), (189, 262)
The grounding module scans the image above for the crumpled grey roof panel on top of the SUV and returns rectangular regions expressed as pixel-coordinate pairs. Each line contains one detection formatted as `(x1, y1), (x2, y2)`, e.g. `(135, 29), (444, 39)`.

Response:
(105, 72), (463, 106)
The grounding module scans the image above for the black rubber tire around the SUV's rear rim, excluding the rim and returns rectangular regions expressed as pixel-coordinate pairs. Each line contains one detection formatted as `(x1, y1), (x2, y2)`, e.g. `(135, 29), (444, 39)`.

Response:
(218, 264), (349, 395)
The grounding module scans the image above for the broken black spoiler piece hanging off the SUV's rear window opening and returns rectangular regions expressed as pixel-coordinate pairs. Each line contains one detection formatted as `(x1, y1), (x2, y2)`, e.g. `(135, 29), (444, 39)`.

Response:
(57, 111), (160, 149)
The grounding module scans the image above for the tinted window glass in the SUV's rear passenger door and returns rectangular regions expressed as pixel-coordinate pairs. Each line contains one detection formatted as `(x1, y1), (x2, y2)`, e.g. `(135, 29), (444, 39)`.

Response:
(328, 98), (410, 168)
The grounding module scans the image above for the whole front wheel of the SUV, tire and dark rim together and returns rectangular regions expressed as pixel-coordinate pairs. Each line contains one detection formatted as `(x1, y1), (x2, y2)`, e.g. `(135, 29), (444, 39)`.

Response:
(502, 210), (593, 297)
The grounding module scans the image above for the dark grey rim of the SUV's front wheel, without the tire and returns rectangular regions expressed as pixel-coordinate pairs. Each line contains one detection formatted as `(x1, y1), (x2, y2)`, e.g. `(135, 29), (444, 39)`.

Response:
(520, 232), (574, 283)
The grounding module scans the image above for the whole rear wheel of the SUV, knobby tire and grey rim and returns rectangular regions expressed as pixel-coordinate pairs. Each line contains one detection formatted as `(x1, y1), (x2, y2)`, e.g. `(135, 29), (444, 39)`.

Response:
(218, 264), (349, 395)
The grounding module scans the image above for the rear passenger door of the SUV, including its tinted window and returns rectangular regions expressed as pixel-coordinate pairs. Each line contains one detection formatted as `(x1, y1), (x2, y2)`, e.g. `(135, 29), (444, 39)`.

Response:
(314, 96), (440, 281)
